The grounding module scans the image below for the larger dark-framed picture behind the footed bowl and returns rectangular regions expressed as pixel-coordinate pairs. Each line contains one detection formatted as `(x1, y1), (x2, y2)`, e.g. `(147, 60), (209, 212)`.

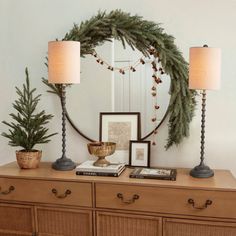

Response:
(99, 112), (141, 165)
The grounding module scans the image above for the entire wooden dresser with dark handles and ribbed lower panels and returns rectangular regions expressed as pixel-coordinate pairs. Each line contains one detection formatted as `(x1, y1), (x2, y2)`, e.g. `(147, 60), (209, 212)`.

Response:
(0, 163), (236, 236)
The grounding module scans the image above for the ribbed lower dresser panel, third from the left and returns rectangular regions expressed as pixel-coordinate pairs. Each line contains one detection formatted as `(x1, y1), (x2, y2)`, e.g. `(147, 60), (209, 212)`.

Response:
(96, 212), (162, 236)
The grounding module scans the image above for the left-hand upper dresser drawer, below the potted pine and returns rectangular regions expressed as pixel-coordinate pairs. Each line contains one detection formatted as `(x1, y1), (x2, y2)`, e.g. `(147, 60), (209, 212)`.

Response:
(0, 178), (92, 207)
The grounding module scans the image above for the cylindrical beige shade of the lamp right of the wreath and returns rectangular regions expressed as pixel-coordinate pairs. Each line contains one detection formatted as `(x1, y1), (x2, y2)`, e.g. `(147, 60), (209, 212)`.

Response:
(189, 47), (221, 90)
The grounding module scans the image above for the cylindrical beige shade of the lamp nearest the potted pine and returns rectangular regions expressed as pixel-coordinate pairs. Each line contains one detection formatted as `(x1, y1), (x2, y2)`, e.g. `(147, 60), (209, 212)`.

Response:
(48, 41), (80, 84)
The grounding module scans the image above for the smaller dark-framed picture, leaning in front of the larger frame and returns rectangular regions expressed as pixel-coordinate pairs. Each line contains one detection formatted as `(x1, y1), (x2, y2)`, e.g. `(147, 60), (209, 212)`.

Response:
(129, 140), (151, 167)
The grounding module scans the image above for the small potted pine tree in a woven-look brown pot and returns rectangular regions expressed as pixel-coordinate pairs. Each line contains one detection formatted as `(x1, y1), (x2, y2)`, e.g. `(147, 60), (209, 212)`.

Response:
(2, 68), (56, 169)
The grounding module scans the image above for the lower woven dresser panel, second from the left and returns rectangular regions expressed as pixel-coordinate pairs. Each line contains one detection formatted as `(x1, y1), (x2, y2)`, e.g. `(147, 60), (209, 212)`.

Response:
(37, 207), (92, 236)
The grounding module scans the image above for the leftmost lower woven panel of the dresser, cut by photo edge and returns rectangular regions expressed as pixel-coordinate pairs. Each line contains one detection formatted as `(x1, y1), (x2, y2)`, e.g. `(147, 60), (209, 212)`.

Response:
(0, 204), (34, 236)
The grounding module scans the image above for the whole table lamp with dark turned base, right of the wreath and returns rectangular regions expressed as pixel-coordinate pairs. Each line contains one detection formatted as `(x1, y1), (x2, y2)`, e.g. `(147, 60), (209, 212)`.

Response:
(189, 45), (221, 178)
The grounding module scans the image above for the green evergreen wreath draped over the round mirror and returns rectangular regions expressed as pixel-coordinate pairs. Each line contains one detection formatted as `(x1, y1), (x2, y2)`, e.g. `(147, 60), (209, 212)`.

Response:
(43, 10), (196, 148)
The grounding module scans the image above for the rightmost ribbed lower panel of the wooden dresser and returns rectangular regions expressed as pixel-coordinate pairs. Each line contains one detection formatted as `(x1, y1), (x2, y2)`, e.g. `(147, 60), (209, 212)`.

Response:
(163, 218), (236, 236)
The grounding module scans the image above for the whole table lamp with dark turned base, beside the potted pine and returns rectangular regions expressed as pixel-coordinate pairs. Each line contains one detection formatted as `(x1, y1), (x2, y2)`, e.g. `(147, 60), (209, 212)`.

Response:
(48, 41), (80, 171)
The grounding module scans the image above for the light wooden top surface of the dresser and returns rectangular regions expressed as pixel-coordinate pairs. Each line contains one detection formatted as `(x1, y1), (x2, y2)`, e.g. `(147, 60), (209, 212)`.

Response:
(0, 162), (236, 191)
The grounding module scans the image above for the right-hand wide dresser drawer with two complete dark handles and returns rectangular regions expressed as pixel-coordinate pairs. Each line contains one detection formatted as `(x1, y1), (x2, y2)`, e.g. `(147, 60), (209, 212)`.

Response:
(96, 183), (236, 218)
